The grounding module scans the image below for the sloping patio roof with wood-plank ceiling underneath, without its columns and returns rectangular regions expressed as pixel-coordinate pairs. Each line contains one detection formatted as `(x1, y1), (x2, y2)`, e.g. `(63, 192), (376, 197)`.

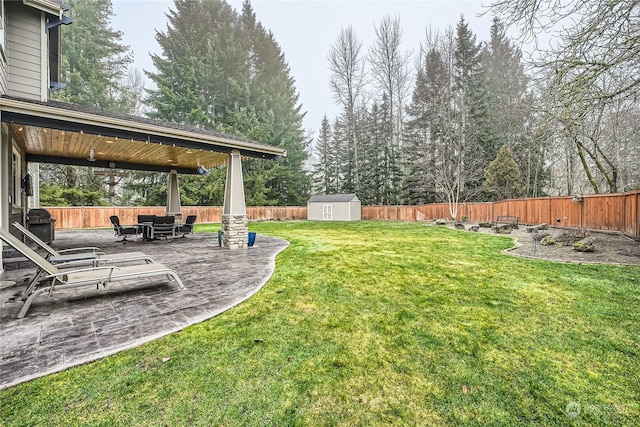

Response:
(0, 97), (286, 174)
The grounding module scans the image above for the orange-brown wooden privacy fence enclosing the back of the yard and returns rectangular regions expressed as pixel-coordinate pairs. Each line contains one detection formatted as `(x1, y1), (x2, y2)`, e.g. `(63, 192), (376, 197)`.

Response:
(46, 191), (640, 238)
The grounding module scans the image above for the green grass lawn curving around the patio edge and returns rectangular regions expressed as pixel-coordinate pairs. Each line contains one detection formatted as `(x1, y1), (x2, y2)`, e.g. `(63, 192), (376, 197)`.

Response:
(0, 221), (640, 426)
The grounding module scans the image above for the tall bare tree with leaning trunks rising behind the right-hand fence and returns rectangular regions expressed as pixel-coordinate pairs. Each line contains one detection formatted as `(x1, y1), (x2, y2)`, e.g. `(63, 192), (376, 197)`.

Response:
(492, 0), (640, 194)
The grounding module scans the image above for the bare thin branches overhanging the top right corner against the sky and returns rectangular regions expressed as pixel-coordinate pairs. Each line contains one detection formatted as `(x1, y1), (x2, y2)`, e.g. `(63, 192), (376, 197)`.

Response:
(491, 0), (640, 104)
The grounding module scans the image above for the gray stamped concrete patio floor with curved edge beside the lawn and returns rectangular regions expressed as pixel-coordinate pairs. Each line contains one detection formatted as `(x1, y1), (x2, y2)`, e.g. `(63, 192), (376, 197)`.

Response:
(0, 230), (289, 389)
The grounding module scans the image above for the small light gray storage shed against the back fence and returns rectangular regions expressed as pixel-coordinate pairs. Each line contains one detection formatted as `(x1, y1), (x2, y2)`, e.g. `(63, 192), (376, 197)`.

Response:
(307, 194), (361, 221)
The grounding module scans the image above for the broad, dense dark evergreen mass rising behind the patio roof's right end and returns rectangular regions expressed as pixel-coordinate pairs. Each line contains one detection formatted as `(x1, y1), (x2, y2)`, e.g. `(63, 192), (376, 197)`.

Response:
(147, 0), (309, 204)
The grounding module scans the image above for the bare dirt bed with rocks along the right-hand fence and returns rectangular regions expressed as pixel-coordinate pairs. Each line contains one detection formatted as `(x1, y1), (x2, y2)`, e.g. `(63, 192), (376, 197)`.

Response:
(450, 223), (640, 265)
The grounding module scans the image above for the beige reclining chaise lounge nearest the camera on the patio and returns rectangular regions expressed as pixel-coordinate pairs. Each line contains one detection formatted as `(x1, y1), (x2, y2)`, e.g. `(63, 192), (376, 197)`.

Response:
(0, 228), (184, 319)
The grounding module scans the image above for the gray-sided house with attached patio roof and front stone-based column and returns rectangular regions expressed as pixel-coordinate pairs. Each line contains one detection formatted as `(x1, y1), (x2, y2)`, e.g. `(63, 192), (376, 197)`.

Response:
(0, 0), (286, 272)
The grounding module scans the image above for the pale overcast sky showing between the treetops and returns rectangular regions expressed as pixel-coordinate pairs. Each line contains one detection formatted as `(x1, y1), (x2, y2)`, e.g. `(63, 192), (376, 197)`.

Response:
(112, 0), (492, 136)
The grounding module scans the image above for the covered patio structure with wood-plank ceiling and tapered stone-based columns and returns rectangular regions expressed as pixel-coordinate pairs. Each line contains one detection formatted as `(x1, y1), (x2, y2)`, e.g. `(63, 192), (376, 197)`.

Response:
(0, 96), (287, 251)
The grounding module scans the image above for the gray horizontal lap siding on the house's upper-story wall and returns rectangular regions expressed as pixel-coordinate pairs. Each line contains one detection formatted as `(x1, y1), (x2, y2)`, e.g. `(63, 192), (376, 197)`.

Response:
(5, 2), (45, 101)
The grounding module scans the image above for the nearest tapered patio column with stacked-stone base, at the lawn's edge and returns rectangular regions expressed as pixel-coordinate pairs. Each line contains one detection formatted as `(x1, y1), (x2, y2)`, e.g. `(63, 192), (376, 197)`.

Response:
(222, 150), (249, 249)
